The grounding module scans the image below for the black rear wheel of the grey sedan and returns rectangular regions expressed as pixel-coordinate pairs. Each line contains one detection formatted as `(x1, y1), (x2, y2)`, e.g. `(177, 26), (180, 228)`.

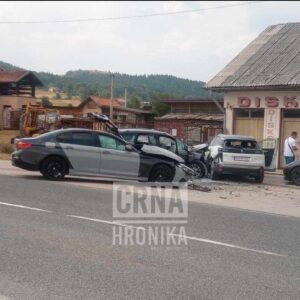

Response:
(40, 157), (68, 180)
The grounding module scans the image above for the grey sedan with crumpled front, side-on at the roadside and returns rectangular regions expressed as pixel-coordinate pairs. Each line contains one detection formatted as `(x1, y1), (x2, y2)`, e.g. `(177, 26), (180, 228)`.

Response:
(12, 129), (193, 182)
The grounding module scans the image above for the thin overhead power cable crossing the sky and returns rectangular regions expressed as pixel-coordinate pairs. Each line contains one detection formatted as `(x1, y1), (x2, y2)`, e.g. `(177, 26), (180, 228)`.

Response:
(0, 1), (262, 24)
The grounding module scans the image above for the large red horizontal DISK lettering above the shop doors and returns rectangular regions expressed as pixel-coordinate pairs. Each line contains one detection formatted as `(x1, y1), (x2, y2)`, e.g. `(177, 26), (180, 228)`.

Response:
(237, 96), (299, 108)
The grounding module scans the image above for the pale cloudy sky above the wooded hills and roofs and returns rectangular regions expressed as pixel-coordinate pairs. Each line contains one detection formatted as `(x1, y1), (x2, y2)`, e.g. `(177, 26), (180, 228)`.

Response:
(0, 1), (300, 82)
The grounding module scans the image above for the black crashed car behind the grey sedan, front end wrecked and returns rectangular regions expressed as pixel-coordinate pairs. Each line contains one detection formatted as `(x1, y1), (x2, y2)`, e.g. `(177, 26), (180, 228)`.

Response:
(118, 129), (207, 178)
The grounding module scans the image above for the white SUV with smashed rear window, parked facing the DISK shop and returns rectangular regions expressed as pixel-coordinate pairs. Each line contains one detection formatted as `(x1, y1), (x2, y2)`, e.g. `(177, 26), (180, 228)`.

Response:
(207, 134), (265, 183)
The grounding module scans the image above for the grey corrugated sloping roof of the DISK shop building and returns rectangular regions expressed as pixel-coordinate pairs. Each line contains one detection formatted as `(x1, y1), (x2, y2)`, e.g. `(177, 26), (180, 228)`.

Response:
(206, 23), (300, 90)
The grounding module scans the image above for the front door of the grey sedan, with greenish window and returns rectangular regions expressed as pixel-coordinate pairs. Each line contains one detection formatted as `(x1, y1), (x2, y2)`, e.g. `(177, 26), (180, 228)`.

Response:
(97, 134), (140, 179)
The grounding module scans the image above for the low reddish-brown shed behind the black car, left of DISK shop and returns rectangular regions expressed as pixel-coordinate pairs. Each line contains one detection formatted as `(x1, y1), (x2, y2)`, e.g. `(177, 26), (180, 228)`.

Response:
(154, 98), (224, 145)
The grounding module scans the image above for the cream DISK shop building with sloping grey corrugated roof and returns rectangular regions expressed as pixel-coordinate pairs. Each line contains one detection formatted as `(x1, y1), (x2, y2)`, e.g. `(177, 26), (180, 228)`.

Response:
(206, 23), (300, 167)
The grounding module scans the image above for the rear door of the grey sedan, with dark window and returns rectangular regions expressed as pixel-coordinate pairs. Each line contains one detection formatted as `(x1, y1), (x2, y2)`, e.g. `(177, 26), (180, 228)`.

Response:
(56, 131), (101, 175)
